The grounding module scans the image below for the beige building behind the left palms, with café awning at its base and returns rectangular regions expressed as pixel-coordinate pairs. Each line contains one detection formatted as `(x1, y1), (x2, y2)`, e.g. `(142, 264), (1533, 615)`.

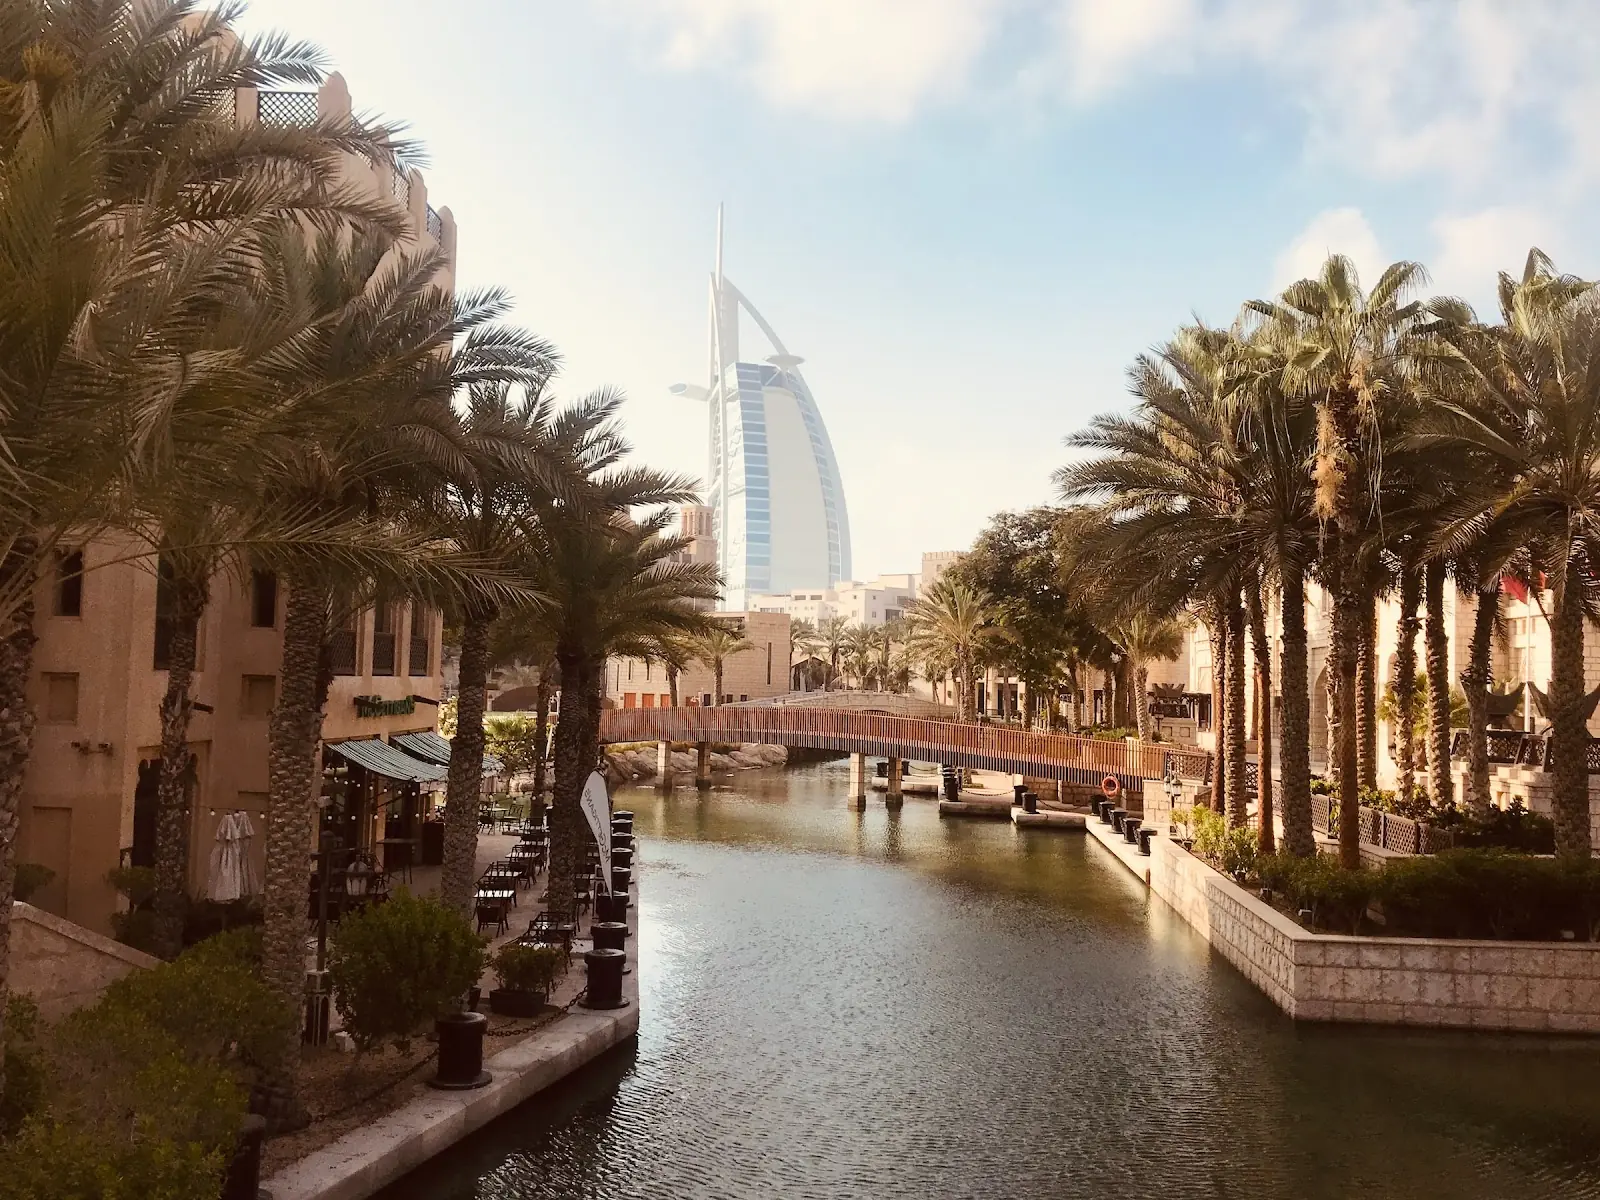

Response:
(18, 75), (456, 933)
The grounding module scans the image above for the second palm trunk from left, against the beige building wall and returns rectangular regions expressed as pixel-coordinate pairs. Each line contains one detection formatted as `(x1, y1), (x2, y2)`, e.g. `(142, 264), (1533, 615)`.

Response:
(154, 573), (208, 958)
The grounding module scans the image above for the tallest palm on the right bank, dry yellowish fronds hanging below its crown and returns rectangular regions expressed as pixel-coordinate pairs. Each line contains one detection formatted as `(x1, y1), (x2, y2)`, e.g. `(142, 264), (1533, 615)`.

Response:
(1250, 254), (1452, 869)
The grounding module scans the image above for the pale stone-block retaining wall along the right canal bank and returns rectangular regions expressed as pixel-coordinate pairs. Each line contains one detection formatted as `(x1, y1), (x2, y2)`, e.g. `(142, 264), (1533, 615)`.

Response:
(1088, 818), (1600, 1034)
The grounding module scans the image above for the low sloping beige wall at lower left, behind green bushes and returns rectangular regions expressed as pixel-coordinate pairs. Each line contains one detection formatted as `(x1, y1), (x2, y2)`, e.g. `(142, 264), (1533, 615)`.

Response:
(11, 902), (158, 1019)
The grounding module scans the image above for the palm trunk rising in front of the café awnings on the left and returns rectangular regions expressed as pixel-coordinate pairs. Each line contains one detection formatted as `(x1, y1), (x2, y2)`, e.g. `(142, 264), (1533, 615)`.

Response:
(438, 606), (494, 918)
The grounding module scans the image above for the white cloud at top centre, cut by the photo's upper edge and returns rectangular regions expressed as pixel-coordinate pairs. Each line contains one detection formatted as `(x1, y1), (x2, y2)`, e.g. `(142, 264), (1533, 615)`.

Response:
(611, 0), (1002, 122)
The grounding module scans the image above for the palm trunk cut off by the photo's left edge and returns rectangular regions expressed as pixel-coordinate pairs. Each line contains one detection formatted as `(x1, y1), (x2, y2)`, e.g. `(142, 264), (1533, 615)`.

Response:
(0, 553), (38, 1094)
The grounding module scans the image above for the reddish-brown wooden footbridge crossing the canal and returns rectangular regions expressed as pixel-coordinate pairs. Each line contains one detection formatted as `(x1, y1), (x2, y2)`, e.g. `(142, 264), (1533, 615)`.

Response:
(600, 704), (1211, 787)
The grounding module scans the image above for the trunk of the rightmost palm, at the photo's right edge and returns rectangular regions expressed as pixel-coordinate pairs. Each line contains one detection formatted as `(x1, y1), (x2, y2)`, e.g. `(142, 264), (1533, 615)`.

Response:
(1544, 585), (1600, 859)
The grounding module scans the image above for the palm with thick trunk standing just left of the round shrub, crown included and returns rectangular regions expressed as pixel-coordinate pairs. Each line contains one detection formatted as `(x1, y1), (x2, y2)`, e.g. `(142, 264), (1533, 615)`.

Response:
(254, 229), (547, 1017)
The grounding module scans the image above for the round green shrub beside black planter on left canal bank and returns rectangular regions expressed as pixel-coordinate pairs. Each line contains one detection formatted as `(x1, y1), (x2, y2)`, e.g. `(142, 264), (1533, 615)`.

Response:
(328, 888), (483, 1051)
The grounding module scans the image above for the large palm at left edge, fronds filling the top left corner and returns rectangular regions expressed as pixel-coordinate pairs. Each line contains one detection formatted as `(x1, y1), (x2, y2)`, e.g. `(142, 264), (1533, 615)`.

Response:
(0, 0), (403, 998)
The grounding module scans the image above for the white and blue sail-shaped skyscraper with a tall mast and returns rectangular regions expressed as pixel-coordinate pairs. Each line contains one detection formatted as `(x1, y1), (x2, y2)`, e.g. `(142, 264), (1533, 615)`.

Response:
(672, 206), (851, 611)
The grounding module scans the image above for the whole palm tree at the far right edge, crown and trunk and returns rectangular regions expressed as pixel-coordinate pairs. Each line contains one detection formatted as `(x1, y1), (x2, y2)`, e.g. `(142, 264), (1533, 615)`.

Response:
(1424, 250), (1600, 859)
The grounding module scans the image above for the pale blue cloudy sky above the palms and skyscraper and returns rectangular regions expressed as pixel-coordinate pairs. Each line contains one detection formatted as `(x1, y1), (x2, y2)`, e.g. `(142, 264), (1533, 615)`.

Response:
(236, 0), (1600, 578)
